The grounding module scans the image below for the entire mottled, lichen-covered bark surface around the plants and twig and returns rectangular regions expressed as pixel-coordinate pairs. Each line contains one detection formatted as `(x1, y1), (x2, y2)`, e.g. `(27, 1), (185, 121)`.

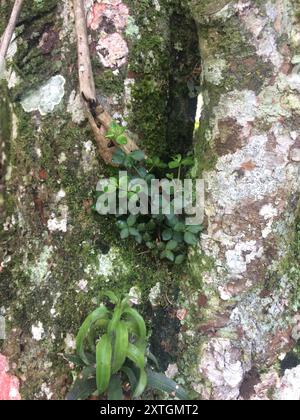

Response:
(0, 0), (300, 399)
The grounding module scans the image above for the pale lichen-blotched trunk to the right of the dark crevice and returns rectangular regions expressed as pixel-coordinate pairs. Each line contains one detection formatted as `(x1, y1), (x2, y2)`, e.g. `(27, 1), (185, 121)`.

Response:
(182, 0), (300, 399)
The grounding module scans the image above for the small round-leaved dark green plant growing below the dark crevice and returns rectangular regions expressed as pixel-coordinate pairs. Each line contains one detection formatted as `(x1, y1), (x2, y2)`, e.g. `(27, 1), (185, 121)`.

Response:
(94, 122), (202, 264)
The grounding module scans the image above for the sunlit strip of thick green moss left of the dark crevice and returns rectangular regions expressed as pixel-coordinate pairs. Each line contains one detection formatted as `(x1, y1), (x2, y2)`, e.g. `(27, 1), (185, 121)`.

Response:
(127, 0), (170, 155)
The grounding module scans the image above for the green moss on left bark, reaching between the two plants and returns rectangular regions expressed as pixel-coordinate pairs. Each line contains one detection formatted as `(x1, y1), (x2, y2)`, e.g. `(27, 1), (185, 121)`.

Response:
(0, 97), (181, 398)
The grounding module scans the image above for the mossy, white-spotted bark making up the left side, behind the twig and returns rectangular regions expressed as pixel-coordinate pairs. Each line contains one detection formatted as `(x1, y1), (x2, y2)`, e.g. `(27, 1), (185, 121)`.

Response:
(0, 0), (199, 399)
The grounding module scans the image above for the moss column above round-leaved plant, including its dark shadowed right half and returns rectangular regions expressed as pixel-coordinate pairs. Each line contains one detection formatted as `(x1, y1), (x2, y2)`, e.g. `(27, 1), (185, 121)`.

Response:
(127, 0), (200, 157)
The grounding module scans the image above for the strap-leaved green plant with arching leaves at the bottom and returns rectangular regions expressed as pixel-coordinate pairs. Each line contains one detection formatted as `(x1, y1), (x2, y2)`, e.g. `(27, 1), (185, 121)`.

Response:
(66, 291), (188, 400)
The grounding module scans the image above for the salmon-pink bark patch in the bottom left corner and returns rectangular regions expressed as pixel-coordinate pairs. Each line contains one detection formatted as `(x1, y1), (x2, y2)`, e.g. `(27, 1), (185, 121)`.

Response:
(0, 354), (21, 401)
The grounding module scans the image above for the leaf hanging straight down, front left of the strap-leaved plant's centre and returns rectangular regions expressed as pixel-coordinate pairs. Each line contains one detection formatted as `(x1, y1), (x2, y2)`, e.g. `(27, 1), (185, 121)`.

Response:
(96, 334), (112, 395)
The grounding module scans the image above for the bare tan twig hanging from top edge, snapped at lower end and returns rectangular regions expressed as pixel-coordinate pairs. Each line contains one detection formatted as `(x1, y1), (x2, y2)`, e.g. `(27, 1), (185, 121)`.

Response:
(73, 0), (138, 164)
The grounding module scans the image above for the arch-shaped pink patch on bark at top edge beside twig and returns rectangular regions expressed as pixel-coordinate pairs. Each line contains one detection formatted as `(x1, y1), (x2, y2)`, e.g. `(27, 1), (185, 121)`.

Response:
(87, 0), (129, 31)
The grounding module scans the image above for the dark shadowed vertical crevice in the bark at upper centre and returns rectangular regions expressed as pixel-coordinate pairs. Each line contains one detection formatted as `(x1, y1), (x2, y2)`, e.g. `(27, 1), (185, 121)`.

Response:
(167, 6), (200, 158)
